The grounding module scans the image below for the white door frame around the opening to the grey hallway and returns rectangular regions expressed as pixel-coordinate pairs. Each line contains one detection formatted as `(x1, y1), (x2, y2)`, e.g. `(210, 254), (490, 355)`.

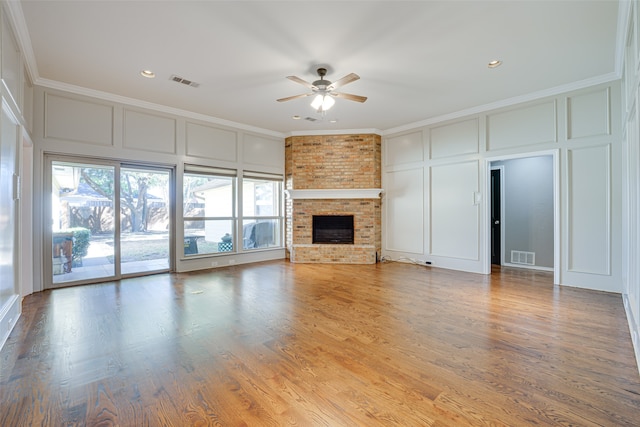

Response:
(483, 149), (561, 285)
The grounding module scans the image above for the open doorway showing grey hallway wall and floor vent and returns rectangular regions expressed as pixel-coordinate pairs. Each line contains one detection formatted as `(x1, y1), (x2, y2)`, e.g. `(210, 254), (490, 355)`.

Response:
(485, 150), (560, 283)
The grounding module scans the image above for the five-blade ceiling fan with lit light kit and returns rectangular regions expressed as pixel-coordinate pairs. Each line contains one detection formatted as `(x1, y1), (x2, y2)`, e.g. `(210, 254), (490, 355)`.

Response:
(277, 68), (367, 113)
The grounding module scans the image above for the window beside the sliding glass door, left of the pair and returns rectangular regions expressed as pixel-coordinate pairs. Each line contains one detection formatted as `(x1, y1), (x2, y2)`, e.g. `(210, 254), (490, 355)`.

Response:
(183, 165), (237, 257)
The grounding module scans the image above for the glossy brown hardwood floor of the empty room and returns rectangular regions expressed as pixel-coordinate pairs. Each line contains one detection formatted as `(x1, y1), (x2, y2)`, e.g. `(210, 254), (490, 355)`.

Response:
(0, 261), (640, 426)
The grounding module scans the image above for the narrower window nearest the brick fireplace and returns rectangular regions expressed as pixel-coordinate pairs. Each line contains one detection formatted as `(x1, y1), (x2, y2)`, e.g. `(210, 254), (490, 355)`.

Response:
(242, 172), (283, 250)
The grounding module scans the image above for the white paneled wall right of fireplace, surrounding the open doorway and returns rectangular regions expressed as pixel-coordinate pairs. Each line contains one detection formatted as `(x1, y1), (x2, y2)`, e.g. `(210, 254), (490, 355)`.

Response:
(383, 82), (622, 292)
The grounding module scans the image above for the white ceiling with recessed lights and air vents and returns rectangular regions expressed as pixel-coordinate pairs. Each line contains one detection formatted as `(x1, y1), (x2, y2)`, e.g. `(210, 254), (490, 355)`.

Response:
(15, 0), (624, 135)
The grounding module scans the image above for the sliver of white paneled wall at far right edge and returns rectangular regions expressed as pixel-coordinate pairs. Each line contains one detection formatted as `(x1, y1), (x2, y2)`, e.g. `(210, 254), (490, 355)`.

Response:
(624, 1), (640, 374)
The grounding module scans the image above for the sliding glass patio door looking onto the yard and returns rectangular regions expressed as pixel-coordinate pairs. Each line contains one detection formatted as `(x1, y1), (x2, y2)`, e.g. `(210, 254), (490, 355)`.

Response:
(44, 156), (173, 288)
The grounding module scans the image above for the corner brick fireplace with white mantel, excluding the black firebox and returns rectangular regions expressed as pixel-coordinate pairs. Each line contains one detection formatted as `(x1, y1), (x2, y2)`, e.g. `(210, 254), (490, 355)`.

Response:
(285, 134), (382, 264)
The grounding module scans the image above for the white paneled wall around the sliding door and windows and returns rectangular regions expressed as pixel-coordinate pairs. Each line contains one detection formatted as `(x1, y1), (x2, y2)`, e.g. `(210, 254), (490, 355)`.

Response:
(33, 86), (285, 291)
